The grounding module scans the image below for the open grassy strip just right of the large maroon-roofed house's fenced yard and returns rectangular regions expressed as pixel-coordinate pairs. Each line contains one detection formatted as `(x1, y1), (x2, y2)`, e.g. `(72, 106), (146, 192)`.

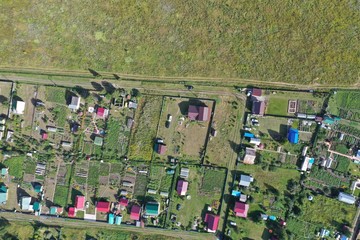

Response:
(205, 96), (244, 166)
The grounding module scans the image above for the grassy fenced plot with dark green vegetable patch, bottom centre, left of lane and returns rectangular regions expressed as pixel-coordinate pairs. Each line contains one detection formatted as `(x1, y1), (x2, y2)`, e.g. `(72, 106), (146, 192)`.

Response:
(168, 166), (225, 230)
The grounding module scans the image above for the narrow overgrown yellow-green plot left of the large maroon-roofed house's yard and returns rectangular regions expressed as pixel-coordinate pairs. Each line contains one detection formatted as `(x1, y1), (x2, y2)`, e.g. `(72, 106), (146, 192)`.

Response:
(129, 95), (162, 161)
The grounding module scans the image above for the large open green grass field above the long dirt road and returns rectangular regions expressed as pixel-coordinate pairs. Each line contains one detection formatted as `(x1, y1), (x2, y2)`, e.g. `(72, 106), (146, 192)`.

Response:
(0, 0), (360, 84)
